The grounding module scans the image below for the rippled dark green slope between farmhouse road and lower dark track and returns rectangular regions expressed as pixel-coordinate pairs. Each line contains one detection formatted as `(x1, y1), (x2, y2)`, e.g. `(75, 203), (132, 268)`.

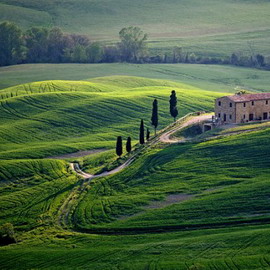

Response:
(73, 128), (270, 231)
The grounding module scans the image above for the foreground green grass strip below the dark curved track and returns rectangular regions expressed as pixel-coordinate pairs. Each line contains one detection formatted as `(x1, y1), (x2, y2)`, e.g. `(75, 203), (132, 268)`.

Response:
(0, 226), (270, 270)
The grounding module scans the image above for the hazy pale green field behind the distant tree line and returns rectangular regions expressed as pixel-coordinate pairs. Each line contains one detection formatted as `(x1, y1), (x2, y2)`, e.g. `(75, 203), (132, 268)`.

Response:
(0, 0), (270, 56)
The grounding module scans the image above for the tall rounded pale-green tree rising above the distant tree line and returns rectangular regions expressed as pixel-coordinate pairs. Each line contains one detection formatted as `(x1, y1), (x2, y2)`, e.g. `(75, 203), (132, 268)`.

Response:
(118, 26), (147, 62)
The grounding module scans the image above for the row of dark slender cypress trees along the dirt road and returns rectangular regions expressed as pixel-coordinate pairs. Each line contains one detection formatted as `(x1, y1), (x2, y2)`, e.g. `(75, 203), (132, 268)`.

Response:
(116, 90), (178, 157)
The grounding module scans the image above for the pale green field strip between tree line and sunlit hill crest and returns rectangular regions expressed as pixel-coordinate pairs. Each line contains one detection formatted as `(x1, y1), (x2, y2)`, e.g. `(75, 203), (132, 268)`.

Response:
(0, 64), (270, 93)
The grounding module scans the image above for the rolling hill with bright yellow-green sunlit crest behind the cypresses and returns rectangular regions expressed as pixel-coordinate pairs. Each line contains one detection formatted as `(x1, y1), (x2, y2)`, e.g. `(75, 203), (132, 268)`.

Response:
(0, 77), (221, 159)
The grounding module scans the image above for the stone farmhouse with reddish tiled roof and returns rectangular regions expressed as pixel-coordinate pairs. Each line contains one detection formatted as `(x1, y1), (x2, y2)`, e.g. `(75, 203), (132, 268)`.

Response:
(215, 93), (270, 124)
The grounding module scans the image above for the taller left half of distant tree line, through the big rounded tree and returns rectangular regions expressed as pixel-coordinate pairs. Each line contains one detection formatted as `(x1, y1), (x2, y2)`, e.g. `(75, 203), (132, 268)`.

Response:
(0, 22), (147, 66)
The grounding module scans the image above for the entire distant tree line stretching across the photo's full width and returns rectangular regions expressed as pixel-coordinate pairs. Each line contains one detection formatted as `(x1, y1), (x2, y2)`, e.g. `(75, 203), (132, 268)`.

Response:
(0, 22), (270, 69)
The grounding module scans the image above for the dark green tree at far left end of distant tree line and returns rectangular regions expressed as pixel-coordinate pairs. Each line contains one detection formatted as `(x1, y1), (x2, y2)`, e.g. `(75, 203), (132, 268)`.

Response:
(0, 22), (24, 66)
